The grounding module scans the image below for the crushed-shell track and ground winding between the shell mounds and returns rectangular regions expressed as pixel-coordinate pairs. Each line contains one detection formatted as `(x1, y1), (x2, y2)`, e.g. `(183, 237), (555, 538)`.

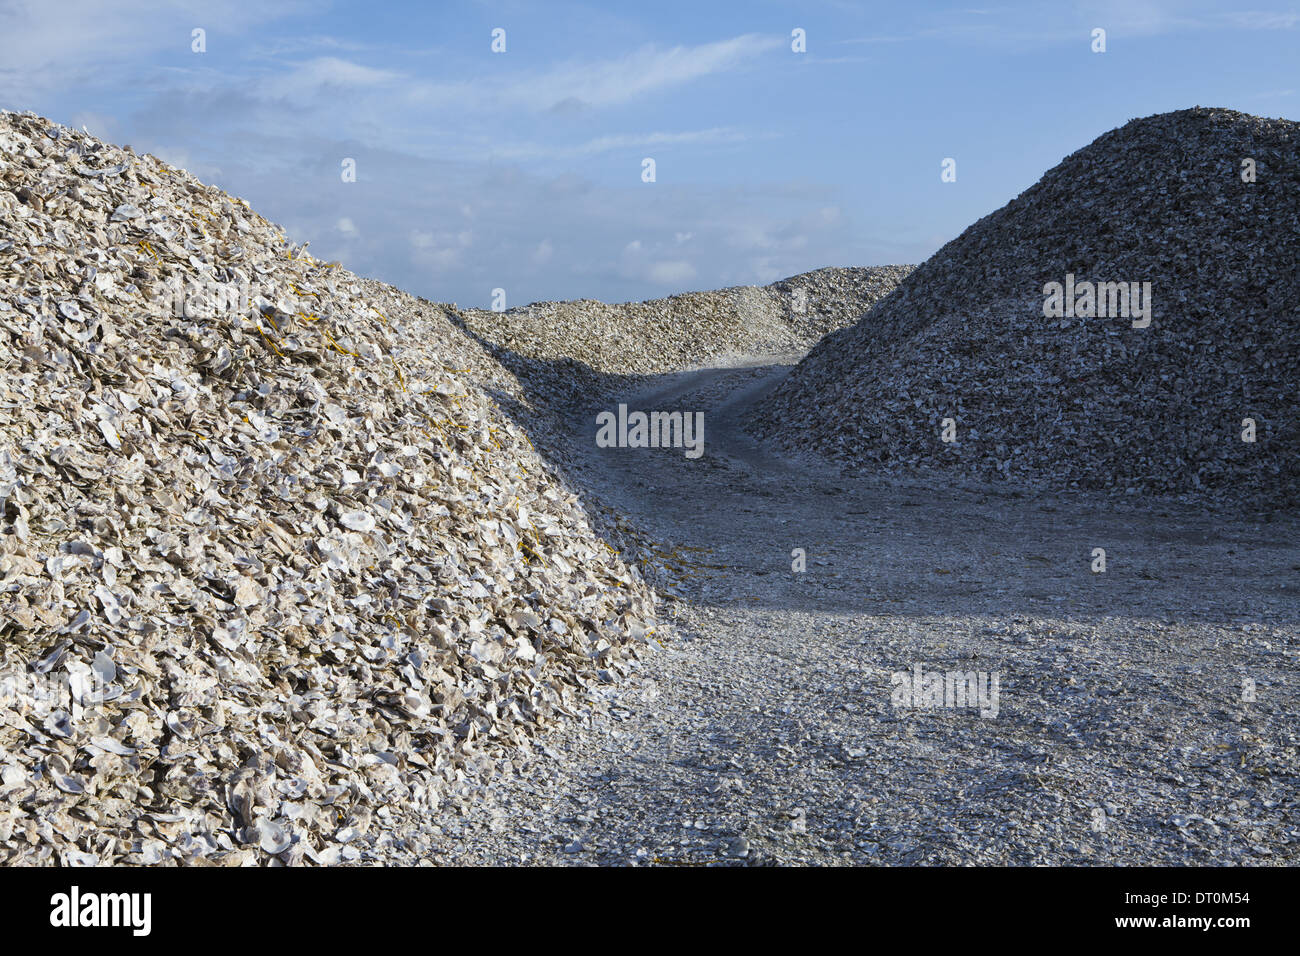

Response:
(408, 356), (1300, 865)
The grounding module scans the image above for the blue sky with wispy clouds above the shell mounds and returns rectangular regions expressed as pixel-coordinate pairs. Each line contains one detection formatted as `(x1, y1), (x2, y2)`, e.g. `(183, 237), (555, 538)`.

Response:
(0, 0), (1300, 306)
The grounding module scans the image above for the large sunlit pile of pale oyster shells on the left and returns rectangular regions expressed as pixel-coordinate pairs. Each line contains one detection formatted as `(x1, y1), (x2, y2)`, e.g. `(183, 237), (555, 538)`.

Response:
(0, 112), (654, 865)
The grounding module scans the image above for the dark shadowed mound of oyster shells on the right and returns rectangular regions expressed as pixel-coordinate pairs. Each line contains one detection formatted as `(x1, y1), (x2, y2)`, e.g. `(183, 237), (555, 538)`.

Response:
(751, 108), (1300, 505)
